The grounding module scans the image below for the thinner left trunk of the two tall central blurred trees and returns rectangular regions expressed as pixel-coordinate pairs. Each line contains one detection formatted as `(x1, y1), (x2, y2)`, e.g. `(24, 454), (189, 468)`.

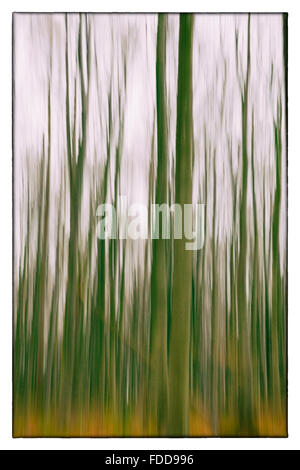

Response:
(150, 14), (168, 434)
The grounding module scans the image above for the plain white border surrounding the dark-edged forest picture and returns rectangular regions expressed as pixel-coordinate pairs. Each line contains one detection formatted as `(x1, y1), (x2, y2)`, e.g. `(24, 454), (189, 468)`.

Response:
(0, 0), (300, 451)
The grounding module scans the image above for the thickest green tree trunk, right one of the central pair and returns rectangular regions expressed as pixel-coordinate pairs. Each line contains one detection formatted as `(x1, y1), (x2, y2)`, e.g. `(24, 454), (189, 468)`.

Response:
(168, 14), (194, 436)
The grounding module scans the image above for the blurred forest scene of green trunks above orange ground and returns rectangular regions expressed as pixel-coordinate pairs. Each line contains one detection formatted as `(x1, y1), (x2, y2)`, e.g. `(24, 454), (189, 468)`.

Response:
(13, 13), (287, 437)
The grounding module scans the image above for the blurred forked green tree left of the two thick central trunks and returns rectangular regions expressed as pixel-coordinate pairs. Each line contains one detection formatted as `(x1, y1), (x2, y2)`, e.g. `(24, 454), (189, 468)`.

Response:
(61, 15), (91, 419)
